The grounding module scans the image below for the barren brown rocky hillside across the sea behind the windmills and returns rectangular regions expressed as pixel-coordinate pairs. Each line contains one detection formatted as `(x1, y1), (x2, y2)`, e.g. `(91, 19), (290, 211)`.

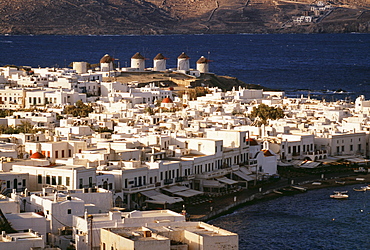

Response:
(0, 0), (370, 35)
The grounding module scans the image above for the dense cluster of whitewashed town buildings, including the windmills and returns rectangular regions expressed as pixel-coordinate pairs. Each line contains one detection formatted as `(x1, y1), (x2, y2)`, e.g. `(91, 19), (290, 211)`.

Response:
(0, 53), (370, 249)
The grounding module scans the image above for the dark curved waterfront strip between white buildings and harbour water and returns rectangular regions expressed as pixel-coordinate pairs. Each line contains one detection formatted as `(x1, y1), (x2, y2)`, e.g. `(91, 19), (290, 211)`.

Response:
(186, 173), (370, 222)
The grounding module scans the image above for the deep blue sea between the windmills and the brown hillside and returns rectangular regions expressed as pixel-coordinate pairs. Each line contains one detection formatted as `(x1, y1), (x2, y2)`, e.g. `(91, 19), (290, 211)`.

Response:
(0, 34), (370, 101)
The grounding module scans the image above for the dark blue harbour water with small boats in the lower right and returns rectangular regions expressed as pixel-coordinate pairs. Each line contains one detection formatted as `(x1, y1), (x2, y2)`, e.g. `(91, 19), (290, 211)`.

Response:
(209, 184), (370, 250)
